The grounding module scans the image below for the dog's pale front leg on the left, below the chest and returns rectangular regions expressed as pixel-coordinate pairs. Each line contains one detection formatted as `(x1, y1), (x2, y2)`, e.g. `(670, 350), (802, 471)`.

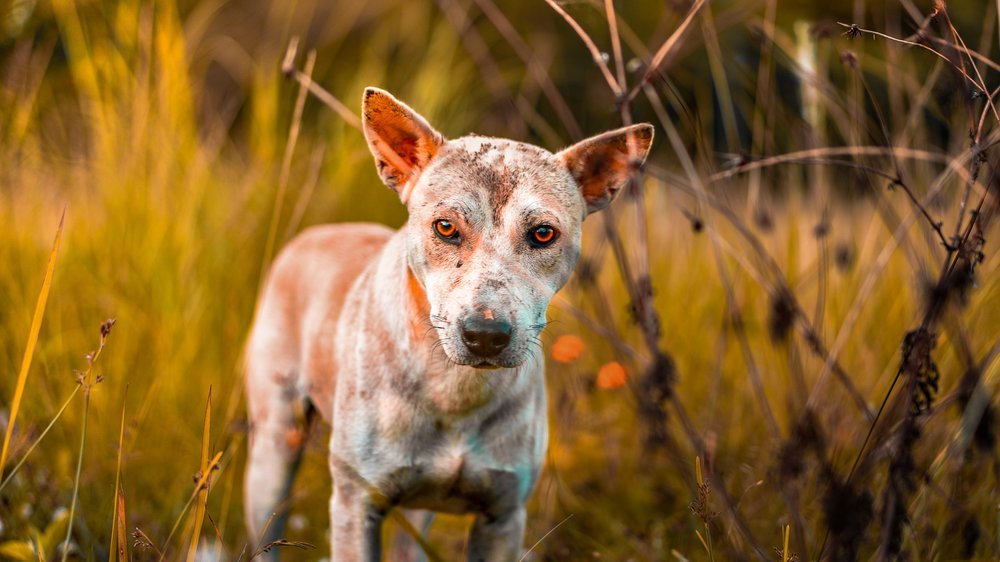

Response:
(330, 475), (385, 562)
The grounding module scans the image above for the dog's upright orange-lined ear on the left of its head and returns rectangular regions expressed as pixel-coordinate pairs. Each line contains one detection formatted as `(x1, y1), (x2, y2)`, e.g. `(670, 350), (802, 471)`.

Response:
(361, 88), (444, 203)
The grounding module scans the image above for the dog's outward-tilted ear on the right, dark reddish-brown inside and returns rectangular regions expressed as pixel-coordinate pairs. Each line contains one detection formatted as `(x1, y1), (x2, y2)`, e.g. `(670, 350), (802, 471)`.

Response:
(556, 123), (653, 213)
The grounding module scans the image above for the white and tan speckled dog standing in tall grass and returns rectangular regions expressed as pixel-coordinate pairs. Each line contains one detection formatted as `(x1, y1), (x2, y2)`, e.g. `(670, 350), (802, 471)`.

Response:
(245, 88), (653, 562)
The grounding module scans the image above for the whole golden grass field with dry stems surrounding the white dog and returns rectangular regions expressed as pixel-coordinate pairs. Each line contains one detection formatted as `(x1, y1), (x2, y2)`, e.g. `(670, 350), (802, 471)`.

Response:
(0, 0), (1000, 562)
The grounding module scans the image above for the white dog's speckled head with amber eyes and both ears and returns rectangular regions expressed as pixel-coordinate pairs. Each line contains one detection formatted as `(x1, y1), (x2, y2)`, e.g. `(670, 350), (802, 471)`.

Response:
(362, 88), (653, 368)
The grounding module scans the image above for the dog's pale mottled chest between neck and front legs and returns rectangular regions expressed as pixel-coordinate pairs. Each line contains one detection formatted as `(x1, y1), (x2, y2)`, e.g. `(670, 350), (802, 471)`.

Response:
(331, 358), (547, 513)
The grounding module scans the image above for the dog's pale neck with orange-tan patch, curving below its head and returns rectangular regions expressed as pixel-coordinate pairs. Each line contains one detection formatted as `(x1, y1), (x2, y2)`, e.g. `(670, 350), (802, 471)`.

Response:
(375, 226), (542, 417)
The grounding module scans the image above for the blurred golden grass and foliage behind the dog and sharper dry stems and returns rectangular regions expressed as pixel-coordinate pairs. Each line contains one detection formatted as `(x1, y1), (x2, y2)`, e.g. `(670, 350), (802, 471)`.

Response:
(0, 0), (1000, 560)
